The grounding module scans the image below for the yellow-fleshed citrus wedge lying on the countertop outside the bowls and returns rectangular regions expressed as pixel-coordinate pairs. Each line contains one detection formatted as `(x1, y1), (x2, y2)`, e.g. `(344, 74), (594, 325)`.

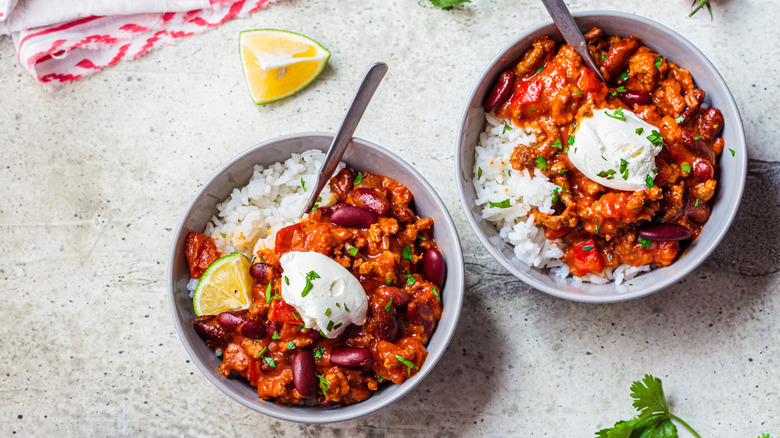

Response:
(238, 29), (330, 105)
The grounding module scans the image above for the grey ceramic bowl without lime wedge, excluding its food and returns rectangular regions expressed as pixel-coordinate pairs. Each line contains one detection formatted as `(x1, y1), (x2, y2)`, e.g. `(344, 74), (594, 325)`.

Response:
(455, 11), (747, 303)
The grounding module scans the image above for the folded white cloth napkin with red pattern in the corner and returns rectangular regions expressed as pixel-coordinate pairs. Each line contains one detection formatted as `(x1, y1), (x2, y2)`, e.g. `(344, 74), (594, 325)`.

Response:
(0, 0), (269, 91)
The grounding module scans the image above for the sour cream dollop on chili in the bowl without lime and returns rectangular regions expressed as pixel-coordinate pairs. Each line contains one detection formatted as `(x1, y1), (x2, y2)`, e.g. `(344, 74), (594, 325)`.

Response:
(568, 108), (661, 192)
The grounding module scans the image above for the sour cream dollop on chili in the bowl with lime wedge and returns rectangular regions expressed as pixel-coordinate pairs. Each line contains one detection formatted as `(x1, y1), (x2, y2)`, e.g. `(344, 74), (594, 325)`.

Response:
(279, 251), (368, 339)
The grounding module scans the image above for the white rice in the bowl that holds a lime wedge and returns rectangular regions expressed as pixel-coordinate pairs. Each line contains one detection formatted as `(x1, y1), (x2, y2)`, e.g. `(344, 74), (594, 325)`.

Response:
(187, 149), (344, 295)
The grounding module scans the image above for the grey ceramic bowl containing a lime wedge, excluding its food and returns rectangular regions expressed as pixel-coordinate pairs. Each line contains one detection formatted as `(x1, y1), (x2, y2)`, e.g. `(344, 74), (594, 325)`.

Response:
(168, 133), (464, 423)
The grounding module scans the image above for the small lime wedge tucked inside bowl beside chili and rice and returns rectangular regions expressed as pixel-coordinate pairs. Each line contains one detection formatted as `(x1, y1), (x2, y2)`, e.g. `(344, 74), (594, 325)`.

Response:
(192, 252), (255, 316)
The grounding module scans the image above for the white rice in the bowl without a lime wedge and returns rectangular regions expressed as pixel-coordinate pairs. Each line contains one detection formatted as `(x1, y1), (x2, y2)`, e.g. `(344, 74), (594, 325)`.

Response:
(474, 114), (650, 285)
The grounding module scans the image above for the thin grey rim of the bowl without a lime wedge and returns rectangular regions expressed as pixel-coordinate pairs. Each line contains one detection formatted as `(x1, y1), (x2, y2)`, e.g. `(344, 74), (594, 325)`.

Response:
(455, 10), (748, 303)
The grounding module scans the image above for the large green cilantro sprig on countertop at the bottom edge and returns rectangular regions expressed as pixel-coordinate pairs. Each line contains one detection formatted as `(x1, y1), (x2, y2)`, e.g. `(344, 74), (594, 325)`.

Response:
(596, 374), (701, 438)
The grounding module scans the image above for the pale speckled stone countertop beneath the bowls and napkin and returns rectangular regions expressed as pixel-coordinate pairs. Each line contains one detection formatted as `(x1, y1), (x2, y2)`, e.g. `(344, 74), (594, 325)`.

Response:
(0, 0), (780, 438)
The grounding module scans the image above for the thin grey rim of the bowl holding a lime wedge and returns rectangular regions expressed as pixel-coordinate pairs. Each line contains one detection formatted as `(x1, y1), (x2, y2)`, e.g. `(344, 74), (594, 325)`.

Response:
(167, 132), (465, 424)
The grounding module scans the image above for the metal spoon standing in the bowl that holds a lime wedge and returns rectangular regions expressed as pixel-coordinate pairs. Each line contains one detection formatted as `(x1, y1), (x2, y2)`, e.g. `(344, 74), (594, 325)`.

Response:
(301, 62), (387, 216)
